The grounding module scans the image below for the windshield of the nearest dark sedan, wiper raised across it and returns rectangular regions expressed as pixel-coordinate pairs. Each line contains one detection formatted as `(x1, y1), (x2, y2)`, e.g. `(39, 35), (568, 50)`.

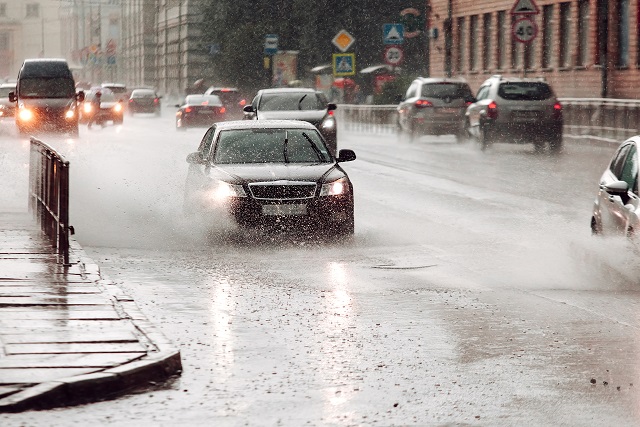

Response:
(214, 129), (331, 164)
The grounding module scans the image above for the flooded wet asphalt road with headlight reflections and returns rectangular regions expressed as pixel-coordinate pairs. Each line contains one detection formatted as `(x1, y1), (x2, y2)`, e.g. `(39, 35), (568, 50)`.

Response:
(0, 111), (640, 426)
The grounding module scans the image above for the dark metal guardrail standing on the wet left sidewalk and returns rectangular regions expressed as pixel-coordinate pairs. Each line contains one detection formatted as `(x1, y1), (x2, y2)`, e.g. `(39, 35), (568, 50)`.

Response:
(29, 138), (73, 266)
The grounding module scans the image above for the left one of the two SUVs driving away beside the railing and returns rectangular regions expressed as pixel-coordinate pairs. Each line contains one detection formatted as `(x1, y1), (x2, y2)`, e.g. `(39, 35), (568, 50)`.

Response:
(397, 77), (475, 142)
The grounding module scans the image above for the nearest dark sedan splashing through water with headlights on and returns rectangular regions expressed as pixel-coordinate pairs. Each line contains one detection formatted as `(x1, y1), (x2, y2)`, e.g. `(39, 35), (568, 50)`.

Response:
(184, 120), (356, 236)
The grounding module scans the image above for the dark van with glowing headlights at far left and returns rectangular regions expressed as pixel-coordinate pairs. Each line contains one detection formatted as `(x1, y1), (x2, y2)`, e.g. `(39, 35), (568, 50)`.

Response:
(9, 59), (84, 136)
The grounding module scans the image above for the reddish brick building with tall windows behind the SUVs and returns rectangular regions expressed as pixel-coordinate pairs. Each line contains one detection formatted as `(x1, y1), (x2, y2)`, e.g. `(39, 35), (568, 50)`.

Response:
(427, 0), (640, 98)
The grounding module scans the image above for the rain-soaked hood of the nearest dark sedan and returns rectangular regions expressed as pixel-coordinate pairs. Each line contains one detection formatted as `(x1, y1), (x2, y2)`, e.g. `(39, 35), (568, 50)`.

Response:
(217, 163), (344, 182)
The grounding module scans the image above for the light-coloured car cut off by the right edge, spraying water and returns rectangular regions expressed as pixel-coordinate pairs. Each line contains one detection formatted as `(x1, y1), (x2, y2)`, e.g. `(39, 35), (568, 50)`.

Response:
(591, 136), (640, 237)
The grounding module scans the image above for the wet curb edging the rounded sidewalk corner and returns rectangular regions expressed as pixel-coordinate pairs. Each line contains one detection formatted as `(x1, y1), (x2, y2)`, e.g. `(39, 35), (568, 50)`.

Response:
(0, 239), (182, 413)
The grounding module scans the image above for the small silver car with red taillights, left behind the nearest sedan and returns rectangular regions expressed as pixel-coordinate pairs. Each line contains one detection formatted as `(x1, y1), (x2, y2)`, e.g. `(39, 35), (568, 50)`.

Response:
(176, 95), (226, 130)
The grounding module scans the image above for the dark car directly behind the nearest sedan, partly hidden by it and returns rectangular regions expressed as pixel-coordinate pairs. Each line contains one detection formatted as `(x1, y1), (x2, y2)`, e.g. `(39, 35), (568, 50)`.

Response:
(244, 88), (338, 156)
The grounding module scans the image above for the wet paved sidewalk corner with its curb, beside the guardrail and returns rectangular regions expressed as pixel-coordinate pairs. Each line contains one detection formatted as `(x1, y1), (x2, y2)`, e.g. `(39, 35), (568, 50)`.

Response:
(0, 213), (182, 412)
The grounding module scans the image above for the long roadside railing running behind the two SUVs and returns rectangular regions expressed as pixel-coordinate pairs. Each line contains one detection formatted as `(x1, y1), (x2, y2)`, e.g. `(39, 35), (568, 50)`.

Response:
(336, 98), (640, 143)
